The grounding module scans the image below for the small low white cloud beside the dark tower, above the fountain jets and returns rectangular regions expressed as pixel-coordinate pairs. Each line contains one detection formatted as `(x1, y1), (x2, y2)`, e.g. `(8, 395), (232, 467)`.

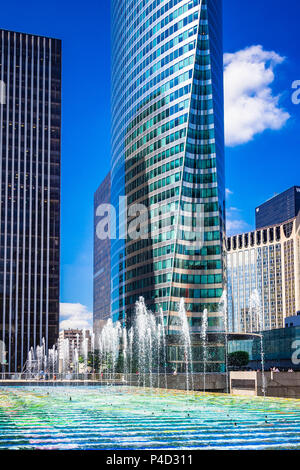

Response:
(59, 303), (93, 330)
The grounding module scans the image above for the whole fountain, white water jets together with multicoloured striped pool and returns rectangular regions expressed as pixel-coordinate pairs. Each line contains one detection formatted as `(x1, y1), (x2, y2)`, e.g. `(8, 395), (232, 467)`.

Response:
(7, 291), (300, 450)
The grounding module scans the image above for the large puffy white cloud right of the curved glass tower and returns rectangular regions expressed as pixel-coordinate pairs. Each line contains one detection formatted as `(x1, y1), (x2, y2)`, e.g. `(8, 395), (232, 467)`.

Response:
(224, 46), (290, 147)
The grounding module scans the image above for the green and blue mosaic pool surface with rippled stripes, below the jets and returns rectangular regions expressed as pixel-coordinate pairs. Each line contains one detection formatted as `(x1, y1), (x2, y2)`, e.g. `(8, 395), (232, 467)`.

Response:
(0, 386), (300, 450)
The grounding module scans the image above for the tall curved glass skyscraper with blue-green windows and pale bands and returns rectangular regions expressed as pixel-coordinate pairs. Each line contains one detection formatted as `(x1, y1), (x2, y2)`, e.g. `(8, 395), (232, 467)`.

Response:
(111, 0), (225, 356)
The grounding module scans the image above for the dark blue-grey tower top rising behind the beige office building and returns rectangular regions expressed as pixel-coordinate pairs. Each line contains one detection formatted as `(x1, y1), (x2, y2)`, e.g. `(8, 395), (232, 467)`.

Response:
(255, 186), (300, 229)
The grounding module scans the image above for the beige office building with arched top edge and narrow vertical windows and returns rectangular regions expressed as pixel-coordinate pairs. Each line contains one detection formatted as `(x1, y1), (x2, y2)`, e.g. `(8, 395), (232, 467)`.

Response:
(227, 214), (300, 333)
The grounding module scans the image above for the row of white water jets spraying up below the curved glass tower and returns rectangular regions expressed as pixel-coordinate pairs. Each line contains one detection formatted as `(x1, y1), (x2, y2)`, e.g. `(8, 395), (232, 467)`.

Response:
(23, 297), (226, 392)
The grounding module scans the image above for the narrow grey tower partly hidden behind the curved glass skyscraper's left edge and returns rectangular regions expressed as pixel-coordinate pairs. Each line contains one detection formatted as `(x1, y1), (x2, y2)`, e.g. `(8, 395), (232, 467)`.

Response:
(93, 173), (110, 338)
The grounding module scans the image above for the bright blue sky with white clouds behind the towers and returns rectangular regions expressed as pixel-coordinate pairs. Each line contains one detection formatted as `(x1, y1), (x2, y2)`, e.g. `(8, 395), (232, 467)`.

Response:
(0, 0), (300, 325)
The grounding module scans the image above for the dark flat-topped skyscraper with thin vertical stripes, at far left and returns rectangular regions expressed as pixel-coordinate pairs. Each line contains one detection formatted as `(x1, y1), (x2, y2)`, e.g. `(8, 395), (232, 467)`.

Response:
(0, 30), (61, 372)
